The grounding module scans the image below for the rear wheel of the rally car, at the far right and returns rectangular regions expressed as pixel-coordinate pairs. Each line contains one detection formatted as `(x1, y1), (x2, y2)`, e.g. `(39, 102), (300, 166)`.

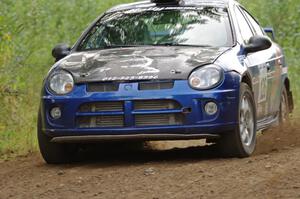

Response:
(279, 86), (290, 125)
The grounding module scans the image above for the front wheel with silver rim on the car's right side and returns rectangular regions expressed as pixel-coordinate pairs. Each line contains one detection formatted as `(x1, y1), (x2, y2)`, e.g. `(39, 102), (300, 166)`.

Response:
(217, 83), (257, 158)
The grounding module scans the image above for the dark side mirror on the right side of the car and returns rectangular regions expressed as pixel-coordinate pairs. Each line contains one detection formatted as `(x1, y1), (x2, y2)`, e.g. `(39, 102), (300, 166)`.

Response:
(244, 35), (272, 53)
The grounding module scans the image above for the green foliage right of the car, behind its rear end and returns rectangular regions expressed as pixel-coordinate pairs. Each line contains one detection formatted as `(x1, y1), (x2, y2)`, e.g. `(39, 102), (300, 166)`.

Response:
(240, 0), (300, 112)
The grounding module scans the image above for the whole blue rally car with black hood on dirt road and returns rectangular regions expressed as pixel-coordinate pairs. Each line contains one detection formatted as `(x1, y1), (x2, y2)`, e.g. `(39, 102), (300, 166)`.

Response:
(38, 0), (293, 164)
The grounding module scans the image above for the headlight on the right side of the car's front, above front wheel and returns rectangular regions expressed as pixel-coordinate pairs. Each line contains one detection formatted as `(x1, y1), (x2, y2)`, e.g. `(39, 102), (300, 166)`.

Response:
(189, 64), (223, 90)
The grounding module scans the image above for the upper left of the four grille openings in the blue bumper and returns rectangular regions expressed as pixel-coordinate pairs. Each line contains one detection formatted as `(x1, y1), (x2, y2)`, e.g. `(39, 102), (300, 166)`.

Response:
(79, 101), (123, 112)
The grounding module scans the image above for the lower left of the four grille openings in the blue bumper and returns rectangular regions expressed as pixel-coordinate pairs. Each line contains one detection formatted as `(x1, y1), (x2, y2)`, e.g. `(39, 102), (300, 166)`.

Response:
(77, 115), (124, 128)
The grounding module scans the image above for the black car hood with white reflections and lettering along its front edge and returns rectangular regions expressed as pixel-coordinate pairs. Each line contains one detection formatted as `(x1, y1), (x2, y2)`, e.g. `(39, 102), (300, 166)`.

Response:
(58, 46), (228, 83)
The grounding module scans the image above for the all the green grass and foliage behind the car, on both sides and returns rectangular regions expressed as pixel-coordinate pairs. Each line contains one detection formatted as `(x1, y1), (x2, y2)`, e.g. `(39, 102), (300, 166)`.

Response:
(0, 0), (300, 157)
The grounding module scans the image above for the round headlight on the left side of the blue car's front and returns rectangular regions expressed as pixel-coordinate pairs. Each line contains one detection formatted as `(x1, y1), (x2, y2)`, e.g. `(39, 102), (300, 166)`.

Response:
(48, 71), (74, 95)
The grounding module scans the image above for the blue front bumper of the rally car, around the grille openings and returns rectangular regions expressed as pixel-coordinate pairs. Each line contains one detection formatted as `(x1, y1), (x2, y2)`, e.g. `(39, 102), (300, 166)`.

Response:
(41, 72), (240, 140)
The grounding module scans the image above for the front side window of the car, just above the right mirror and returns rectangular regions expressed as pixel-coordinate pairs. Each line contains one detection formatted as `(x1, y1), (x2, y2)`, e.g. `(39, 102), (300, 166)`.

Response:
(235, 7), (253, 43)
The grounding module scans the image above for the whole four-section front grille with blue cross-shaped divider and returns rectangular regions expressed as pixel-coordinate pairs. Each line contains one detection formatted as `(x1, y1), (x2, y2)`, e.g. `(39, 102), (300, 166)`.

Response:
(76, 100), (185, 128)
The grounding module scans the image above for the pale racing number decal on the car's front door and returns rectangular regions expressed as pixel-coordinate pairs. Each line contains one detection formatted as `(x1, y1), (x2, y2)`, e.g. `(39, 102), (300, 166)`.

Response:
(258, 64), (268, 103)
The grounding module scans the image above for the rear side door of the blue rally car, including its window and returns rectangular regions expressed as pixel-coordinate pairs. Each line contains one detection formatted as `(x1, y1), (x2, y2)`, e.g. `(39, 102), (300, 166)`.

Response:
(241, 8), (284, 116)
